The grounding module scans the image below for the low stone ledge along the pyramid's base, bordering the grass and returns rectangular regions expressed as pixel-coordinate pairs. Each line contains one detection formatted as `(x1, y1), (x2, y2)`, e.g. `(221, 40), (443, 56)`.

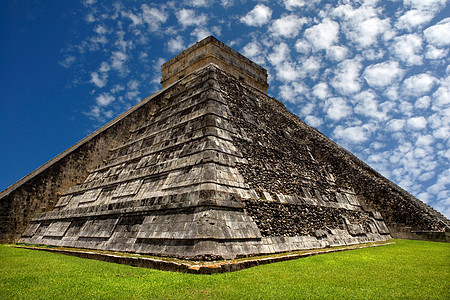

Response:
(10, 241), (395, 274)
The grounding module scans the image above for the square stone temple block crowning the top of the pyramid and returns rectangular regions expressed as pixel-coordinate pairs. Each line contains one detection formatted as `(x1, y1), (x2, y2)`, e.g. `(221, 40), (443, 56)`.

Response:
(161, 36), (269, 93)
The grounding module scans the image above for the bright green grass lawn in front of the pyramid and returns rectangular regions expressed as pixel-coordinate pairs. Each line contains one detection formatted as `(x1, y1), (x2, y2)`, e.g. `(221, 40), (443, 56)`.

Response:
(0, 240), (450, 299)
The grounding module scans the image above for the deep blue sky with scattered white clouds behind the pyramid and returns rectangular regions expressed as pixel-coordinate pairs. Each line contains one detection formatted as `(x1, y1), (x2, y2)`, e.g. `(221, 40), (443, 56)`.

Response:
(0, 0), (450, 217)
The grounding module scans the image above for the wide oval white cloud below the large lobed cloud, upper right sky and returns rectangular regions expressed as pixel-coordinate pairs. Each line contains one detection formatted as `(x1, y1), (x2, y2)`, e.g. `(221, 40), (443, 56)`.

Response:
(363, 61), (405, 88)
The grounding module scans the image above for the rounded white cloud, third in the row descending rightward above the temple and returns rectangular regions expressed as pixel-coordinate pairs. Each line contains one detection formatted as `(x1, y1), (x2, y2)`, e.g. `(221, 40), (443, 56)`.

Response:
(304, 19), (339, 50)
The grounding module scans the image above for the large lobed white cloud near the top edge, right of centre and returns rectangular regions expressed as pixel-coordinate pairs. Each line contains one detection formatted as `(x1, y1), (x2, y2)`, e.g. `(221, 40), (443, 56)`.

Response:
(331, 4), (391, 48)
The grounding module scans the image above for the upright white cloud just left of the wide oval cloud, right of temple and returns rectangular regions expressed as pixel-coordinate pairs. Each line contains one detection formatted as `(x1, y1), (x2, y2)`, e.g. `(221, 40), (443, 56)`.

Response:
(331, 59), (362, 95)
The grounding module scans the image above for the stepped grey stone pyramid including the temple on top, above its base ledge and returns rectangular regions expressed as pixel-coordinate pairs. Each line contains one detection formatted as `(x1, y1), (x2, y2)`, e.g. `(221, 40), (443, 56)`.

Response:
(0, 37), (448, 259)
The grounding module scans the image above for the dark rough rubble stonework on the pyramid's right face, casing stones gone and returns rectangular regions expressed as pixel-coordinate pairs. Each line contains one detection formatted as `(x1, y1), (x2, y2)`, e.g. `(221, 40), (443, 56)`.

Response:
(217, 66), (450, 240)
